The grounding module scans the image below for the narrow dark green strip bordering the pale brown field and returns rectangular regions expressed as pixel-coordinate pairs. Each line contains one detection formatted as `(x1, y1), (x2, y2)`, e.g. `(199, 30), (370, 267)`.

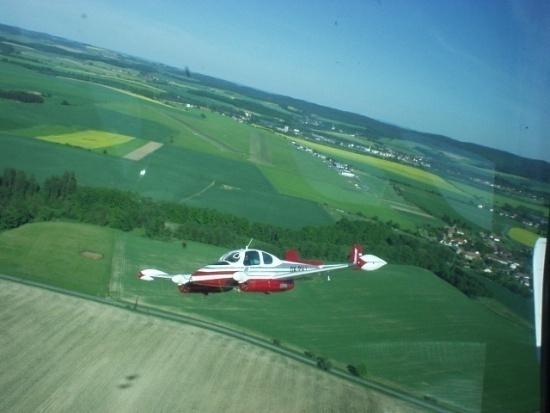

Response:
(0, 274), (466, 413)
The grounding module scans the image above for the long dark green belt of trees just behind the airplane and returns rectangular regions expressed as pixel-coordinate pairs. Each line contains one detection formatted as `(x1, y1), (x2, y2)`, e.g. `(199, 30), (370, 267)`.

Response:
(0, 169), (490, 296)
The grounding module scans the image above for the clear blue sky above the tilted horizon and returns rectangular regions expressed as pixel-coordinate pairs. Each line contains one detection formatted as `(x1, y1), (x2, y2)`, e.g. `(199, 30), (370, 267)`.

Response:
(0, 0), (550, 161)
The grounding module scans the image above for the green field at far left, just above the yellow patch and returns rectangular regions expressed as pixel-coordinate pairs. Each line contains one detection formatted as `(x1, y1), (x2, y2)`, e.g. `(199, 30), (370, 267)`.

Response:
(0, 62), (177, 141)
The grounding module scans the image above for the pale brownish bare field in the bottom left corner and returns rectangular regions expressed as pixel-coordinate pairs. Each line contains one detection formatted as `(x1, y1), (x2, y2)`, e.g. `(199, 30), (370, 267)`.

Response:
(0, 280), (415, 413)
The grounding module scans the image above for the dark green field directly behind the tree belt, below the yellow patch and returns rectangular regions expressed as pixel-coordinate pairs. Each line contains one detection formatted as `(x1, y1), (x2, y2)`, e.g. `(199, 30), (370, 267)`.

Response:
(0, 134), (332, 227)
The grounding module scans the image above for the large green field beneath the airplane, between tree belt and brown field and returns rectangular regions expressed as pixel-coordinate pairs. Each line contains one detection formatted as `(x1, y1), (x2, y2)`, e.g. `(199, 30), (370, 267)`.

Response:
(0, 223), (538, 412)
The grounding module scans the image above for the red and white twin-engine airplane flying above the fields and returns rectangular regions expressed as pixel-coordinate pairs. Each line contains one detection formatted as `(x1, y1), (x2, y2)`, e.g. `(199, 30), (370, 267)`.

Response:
(138, 244), (386, 294)
